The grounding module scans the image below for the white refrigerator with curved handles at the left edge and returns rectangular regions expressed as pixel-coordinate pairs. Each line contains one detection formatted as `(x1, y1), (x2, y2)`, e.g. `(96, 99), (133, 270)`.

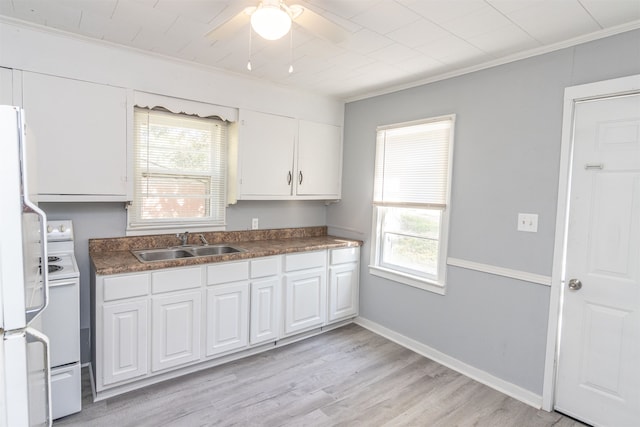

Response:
(0, 105), (51, 427)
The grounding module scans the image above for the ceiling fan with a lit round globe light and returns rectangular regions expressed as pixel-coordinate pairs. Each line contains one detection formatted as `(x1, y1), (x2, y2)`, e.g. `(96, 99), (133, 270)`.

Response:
(206, 0), (348, 43)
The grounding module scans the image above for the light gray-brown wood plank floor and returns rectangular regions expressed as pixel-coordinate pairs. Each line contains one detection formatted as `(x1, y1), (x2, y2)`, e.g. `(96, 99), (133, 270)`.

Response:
(54, 325), (583, 427)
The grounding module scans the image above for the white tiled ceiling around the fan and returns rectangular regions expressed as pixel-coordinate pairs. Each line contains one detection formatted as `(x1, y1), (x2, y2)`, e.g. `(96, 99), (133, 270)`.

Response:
(0, 0), (640, 99)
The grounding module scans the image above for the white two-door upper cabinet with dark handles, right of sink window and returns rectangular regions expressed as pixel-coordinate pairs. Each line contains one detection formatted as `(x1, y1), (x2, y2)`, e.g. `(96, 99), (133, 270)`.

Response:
(230, 110), (342, 200)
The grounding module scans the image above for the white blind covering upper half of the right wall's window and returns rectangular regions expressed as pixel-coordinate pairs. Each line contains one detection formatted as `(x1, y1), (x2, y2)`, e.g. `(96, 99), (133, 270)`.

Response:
(373, 118), (452, 208)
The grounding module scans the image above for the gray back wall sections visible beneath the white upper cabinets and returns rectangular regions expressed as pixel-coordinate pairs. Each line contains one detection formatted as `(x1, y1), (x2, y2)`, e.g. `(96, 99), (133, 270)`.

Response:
(40, 201), (326, 363)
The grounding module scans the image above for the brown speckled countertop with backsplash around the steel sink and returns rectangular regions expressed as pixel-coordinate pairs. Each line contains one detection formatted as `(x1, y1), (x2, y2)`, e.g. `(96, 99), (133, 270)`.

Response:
(89, 227), (362, 275)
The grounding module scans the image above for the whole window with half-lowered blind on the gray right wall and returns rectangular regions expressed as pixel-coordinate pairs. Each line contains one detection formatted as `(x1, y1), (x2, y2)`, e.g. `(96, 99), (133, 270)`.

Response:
(371, 115), (455, 292)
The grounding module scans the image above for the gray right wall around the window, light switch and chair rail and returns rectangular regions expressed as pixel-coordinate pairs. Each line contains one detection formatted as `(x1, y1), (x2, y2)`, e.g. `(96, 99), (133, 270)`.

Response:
(327, 31), (640, 395)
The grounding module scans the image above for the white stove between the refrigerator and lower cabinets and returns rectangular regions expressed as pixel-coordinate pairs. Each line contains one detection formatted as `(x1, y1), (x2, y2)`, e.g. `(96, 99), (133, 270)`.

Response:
(42, 220), (82, 420)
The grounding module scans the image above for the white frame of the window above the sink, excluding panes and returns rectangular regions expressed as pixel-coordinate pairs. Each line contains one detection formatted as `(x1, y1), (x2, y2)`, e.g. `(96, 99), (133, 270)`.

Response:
(126, 105), (229, 236)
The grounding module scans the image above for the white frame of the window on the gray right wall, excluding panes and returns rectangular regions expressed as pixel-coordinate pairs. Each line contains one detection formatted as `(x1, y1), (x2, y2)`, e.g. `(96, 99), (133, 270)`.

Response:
(369, 114), (456, 295)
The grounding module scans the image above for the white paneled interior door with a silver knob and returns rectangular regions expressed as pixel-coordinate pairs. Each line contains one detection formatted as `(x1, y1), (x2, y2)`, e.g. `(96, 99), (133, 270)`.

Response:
(555, 93), (640, 427)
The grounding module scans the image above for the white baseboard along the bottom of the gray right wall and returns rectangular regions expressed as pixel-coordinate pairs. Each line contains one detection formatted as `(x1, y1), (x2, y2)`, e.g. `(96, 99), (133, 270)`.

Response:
(355, 317), (542, 409)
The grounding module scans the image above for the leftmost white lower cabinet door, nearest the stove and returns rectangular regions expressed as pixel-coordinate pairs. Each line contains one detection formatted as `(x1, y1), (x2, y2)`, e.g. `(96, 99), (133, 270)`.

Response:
(102, 301), (148, 385)
